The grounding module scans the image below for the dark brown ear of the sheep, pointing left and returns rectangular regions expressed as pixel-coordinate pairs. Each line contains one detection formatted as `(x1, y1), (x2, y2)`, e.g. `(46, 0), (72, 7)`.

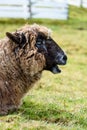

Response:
(6, 32), (26, 47)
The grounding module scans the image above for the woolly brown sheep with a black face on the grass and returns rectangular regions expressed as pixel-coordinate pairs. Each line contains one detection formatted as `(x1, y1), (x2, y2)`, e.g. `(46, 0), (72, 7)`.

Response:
(0, 24), (67, 115)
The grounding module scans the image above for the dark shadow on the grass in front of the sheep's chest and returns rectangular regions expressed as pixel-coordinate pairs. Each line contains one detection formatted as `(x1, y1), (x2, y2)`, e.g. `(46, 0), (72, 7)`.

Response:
(19, 101), (74, 125)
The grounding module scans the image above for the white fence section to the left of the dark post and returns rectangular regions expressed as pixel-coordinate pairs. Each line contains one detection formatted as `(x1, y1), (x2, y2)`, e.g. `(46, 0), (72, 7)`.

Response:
(0, 0), (30, 18)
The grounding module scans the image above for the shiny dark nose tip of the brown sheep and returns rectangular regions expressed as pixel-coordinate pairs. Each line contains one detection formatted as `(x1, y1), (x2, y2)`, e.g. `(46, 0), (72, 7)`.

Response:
(56, 54), (67, 65)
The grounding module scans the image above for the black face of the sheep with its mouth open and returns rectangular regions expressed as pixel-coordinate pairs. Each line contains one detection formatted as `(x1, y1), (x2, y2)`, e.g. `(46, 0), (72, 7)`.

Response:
(36, 33), (67, 74)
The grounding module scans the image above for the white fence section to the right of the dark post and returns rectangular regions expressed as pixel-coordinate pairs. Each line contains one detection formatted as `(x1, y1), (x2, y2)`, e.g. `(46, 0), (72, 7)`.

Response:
(32, 0), (68, 19)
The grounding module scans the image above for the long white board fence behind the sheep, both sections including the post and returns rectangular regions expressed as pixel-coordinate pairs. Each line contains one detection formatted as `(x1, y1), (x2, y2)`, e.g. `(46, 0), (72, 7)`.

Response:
(0, 0), (68, 19)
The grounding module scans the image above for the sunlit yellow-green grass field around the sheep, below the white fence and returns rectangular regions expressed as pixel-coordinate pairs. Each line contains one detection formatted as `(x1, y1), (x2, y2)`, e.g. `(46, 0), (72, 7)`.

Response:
(0, 7), (87, 130)
